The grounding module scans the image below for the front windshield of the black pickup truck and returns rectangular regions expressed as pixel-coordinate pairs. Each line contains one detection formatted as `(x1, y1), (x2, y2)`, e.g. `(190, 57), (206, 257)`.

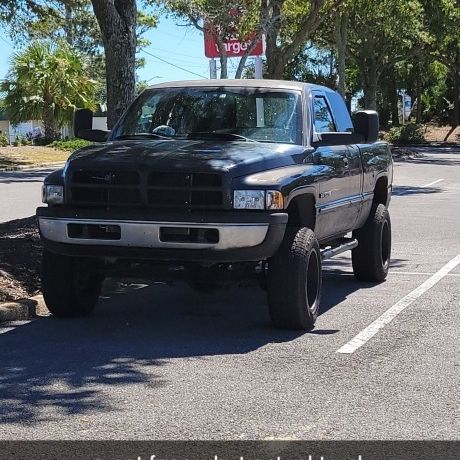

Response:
(112, 88), (301, 144)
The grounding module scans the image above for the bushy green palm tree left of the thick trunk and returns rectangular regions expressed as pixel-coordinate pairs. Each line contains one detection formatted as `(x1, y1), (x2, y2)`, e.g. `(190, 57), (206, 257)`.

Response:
(1, 41), (97, 139)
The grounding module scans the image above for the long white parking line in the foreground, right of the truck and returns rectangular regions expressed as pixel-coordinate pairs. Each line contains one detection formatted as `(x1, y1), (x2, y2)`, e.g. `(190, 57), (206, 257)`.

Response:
(337, 254), (460, 354)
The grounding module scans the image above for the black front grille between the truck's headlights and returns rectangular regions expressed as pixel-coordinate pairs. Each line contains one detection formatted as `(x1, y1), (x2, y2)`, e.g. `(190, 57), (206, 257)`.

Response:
(70, 170), (223, 209)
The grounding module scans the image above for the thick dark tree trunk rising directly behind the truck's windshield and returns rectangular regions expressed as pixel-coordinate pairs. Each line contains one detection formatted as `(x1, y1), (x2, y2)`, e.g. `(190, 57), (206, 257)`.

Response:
(91, 0), (137, 129)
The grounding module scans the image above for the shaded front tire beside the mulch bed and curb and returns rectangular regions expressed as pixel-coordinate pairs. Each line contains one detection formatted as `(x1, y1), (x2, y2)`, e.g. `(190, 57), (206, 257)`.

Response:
(42, 251), (103, 318)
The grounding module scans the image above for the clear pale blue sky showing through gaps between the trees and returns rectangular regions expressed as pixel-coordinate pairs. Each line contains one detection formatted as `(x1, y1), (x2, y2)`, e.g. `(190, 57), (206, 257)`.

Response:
(0, 17), (256, 84)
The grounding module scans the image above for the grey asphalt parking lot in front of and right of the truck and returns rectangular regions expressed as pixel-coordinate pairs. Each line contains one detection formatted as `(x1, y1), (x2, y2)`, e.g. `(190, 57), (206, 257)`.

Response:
(0, 150), (460, 440)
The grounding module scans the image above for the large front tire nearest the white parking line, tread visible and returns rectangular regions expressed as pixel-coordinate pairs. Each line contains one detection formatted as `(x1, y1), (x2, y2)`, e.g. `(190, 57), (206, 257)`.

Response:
(267, 227), (321, 330)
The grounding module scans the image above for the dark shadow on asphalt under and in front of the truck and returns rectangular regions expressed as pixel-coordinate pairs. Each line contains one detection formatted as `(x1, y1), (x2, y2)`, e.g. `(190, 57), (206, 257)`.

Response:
(0, 262), (398, 426)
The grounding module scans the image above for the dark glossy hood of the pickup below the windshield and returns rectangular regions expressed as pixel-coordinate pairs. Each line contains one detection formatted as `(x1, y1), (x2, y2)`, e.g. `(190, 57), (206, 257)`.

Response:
(68, 140), (307, 177)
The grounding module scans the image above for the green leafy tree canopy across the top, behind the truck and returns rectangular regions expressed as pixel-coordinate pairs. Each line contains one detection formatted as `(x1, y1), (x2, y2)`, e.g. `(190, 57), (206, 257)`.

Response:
(0, 0), (460, 135)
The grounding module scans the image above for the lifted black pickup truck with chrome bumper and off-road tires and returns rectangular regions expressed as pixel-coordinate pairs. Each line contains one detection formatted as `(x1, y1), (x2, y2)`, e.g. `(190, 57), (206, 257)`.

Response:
(37, 80), (393, 329)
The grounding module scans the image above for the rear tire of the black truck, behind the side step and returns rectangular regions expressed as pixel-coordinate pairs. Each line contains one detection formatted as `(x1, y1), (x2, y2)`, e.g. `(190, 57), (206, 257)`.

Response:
(351, 204), (391, 282)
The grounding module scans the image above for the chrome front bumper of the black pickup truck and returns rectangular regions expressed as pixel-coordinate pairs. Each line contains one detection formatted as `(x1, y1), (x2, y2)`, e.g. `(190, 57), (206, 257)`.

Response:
(38, 216), (269, 251)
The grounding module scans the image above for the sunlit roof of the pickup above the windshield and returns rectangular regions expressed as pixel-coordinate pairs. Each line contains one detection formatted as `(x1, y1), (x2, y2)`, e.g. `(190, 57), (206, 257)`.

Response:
(147, 78), (333, 92)
